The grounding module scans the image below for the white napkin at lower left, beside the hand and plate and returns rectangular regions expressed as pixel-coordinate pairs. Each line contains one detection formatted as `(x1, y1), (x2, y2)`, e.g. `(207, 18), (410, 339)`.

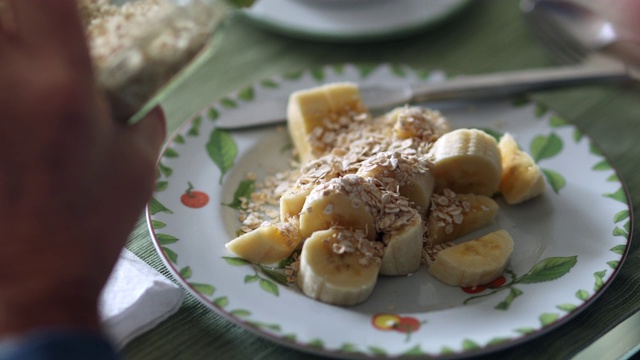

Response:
(100, 249), (184, 348)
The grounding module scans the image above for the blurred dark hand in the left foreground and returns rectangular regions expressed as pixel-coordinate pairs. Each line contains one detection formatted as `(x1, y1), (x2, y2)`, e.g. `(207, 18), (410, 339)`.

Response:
(0, 0), (165, 336)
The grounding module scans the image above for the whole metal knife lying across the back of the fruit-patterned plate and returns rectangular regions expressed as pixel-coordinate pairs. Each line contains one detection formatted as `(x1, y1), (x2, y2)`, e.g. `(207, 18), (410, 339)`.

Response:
(216, 56), (640, 130)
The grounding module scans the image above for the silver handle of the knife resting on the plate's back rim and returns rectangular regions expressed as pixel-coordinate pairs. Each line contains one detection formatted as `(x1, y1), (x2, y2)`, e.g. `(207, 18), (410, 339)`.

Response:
(411, 61), (631, 103)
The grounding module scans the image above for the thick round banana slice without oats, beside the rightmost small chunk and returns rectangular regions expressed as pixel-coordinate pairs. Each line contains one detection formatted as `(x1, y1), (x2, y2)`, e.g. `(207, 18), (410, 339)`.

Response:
(428, 129), (502, 196)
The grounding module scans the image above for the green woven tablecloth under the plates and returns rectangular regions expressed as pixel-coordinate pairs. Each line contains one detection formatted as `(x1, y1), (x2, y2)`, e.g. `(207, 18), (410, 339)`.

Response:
(124, 0), (640, 359)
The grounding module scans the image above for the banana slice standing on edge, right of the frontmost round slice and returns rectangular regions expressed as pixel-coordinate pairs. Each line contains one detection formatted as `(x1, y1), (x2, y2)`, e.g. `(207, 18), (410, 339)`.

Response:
(380, 209), (424, 275)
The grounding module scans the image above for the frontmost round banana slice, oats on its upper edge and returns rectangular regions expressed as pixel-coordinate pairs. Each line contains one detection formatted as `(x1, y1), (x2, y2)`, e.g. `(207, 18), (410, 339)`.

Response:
(297, 228), (380, 305)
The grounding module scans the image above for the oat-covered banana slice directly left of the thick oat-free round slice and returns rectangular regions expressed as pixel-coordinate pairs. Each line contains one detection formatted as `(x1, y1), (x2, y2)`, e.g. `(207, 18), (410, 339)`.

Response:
(356, 149), (435, 209)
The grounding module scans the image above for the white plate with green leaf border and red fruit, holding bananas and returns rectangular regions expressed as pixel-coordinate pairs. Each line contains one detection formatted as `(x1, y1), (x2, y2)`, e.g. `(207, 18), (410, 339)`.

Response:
(147, 65), (631, 358)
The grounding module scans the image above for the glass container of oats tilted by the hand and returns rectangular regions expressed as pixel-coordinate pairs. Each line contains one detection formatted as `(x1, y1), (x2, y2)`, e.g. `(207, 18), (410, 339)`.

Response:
(78, 0), (238, 122)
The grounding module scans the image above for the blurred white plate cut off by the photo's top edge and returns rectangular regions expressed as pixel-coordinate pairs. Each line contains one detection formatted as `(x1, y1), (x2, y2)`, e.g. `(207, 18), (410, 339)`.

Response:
(243, 0), (470, 41)
